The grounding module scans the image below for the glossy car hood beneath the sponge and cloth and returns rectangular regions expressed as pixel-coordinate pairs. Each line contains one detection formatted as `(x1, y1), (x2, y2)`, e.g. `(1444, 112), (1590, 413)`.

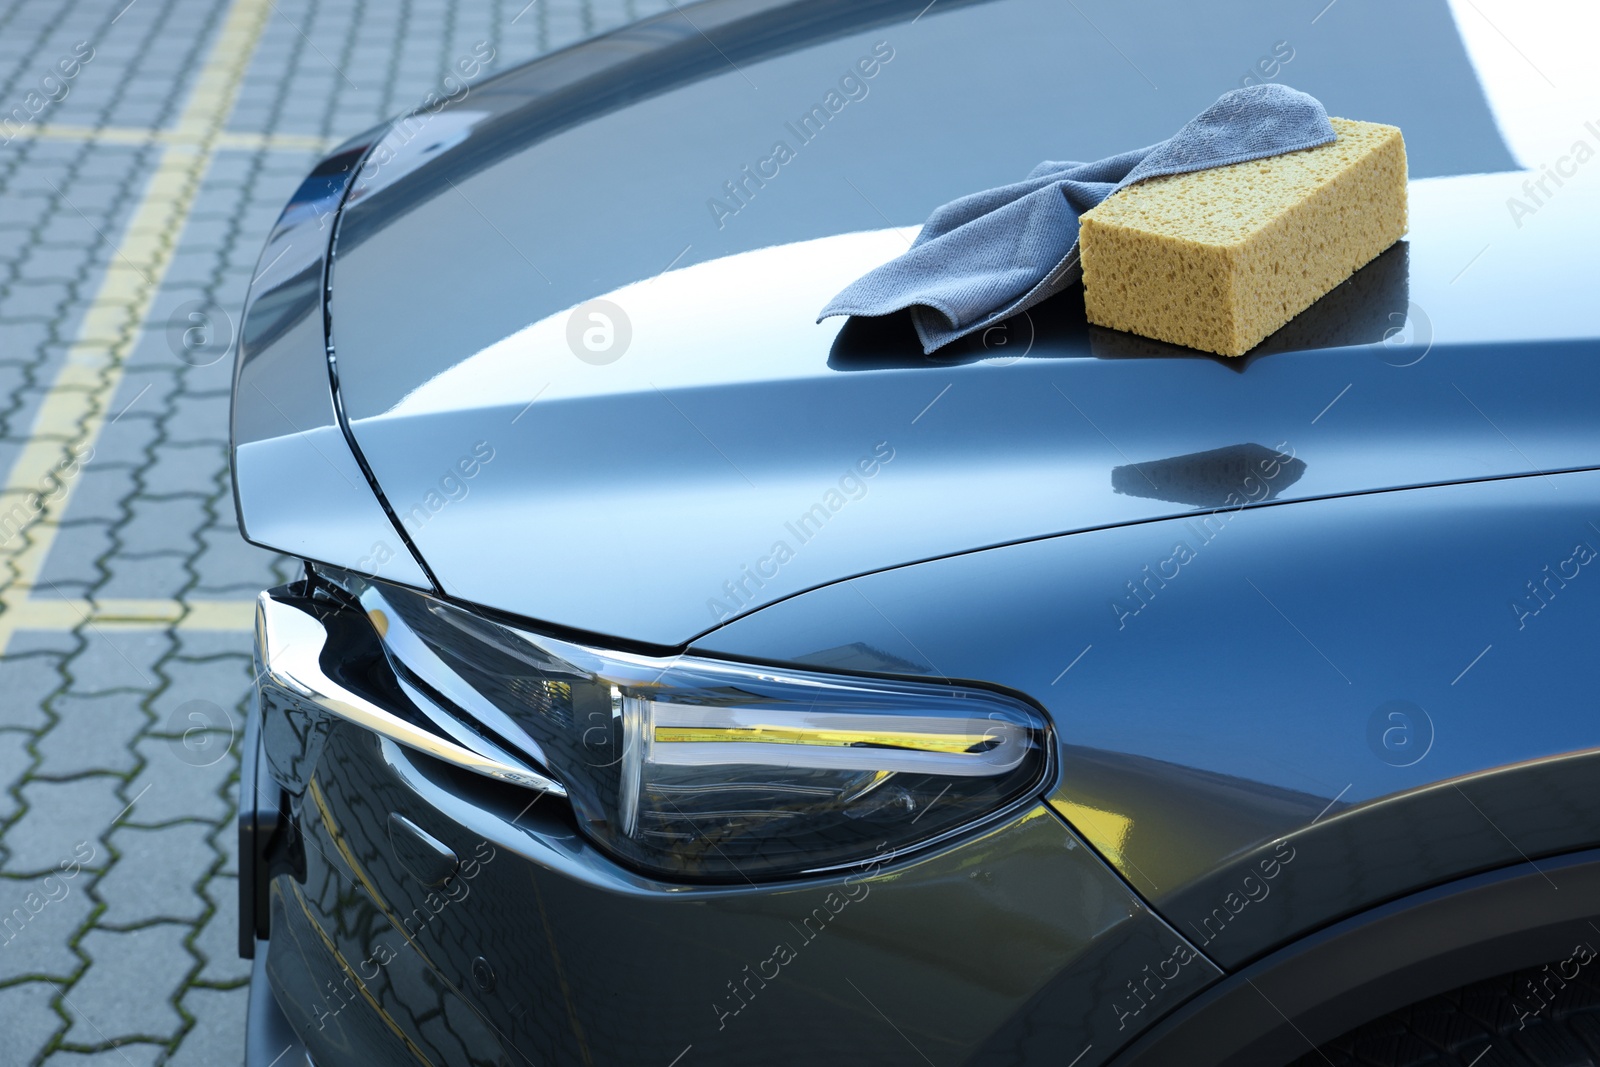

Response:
(318, 0), (1600, 646)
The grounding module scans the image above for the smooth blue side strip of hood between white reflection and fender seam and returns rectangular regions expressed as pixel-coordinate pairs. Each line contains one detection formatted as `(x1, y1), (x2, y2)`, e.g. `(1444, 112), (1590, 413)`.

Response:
(334, 302), (1600, 646)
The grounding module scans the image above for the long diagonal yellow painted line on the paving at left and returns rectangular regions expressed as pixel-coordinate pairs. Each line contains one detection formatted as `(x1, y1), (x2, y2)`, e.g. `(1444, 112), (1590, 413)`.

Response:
(0, 0), (272, 653)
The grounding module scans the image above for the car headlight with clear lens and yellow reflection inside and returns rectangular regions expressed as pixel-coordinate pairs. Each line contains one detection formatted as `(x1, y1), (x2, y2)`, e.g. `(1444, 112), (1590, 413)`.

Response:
(330, 574), (1050, 881)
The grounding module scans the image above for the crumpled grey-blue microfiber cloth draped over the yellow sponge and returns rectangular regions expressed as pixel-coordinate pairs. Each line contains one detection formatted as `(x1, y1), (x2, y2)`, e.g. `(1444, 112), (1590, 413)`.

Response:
(816, 83), (1334, 352)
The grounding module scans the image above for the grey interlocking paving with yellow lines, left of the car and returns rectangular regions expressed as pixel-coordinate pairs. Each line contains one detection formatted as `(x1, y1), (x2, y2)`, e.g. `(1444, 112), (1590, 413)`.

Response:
(0, 0), (674, 1067)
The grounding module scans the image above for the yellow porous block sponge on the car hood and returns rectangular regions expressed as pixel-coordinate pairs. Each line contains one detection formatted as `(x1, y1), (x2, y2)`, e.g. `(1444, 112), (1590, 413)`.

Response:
(1078, 118), (1406, 355)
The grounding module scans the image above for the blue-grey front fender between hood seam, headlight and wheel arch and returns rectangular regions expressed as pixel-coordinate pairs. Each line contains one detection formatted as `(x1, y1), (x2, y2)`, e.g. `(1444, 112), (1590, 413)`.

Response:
(707, 472), (1600, 966)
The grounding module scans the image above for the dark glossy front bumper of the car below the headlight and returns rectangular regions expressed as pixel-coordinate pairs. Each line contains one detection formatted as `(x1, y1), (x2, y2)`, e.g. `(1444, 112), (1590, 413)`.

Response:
(242, 587), (1218, 1067)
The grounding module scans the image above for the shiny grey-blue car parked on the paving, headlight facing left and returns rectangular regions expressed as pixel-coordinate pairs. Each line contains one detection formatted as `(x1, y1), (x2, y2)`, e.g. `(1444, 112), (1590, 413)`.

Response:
(232, 0), (1600, 1067)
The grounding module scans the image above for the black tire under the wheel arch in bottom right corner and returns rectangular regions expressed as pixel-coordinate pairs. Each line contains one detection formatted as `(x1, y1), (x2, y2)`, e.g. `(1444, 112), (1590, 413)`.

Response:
(1290, 944), (1600, 1067)
